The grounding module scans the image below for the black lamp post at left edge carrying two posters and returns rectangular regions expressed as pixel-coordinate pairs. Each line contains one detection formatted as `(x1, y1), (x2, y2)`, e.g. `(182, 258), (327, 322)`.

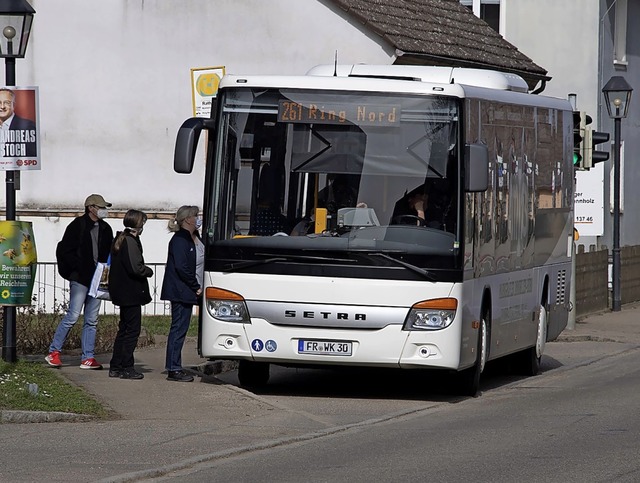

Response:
(0, 0), (36, 362)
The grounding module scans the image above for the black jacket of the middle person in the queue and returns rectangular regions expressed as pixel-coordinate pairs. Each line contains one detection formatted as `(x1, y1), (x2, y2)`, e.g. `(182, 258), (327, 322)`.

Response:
(109, 230), (153, 306)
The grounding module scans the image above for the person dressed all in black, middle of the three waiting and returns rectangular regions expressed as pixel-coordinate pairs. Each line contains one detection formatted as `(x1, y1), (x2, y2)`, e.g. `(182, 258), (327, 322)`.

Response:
(109, 210), (153, 379)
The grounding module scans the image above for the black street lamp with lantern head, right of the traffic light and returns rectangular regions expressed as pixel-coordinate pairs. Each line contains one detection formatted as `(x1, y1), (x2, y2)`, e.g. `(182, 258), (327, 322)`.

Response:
(602, 76), (633, 312)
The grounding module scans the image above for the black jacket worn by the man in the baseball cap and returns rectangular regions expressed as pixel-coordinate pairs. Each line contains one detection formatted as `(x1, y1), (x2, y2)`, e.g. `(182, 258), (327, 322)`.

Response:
(56, 213), (113, 287)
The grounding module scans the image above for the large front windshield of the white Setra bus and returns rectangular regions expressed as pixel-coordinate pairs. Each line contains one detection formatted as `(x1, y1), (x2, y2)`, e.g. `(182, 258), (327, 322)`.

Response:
(205, 88), (462, 269)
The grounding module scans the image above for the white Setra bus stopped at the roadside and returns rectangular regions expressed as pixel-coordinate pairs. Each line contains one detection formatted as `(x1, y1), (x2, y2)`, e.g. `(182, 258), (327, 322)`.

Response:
(174, 65), (574, 395)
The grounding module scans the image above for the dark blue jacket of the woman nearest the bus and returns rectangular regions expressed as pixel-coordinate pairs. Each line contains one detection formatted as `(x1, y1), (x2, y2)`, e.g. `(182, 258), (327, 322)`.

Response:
(160, 228), (200, 305)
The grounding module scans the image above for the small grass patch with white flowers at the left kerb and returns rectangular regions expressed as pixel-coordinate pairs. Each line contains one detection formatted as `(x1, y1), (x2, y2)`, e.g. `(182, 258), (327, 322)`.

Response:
(0, 360), (108, 418)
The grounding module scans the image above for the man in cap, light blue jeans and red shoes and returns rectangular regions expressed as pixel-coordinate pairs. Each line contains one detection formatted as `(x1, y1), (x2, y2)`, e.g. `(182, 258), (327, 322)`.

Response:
(45, 194), (113, 369)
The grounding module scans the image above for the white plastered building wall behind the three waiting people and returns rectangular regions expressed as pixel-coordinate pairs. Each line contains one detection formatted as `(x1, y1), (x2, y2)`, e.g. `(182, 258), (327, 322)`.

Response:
(0, 0), (394, 262)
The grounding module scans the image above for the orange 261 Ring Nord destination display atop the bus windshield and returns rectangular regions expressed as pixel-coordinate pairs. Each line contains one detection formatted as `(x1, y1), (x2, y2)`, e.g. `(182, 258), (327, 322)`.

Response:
(278, 99), (400, 126)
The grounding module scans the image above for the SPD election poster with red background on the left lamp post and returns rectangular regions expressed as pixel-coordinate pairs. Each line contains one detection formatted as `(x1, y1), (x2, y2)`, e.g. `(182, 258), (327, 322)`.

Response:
(0, 86), (41, 171)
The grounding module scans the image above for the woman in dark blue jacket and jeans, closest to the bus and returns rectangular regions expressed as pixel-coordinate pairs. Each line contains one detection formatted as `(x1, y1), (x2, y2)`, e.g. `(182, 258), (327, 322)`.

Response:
(160, 205), (204, 382)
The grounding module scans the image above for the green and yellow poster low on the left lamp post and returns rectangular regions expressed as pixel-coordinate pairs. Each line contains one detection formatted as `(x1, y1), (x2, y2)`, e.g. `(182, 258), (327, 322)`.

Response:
(0, 221), (38, 305)
